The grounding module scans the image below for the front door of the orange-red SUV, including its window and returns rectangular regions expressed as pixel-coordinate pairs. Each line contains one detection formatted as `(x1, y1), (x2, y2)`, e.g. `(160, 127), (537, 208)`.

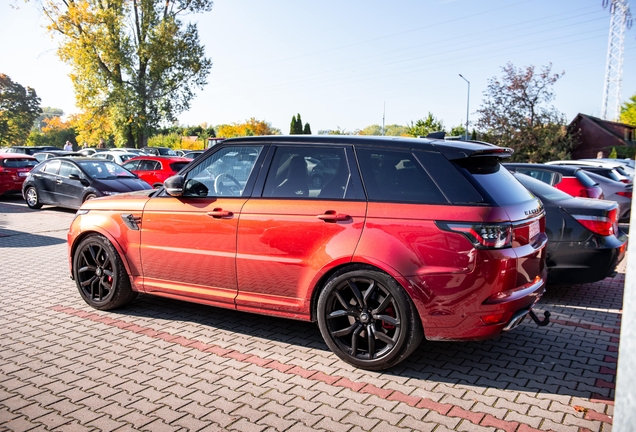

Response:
(141, 146), (263, 307)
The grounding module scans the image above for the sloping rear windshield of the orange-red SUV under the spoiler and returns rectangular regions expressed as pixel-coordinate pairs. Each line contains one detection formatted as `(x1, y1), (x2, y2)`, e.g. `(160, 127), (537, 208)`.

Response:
(454, 157), (540, 206)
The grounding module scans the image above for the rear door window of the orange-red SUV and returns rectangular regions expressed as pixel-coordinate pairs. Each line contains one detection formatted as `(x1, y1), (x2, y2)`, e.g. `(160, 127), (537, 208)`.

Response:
(263, 146), (354, 199)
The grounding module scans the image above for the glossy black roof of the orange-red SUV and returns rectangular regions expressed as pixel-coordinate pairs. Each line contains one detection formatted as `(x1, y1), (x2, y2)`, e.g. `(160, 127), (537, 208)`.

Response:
(219, 135), (513, 159)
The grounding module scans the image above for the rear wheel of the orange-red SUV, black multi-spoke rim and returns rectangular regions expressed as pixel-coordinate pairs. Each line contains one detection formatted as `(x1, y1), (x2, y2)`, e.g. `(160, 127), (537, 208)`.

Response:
(317, 266), (423, 370)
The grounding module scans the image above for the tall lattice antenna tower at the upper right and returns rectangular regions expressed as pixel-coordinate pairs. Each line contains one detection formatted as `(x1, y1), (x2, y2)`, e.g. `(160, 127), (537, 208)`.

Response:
(601, 0), (632, 121)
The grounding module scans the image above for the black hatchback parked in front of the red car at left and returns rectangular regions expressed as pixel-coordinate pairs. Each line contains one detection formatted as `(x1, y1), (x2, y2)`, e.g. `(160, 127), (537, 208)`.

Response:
(22, 157), (152, 209)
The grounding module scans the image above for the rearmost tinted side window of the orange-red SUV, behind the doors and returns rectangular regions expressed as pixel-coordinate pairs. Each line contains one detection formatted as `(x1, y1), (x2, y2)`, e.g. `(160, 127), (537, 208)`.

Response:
(357, 149), (448, 204)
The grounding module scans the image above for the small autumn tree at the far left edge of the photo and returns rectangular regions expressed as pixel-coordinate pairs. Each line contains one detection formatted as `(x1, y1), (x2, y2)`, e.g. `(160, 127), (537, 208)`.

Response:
(0, 74), (42, 146)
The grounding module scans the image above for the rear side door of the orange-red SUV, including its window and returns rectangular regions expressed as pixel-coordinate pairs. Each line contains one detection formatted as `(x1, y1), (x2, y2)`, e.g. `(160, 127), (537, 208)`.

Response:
(236, 145), (366, 319)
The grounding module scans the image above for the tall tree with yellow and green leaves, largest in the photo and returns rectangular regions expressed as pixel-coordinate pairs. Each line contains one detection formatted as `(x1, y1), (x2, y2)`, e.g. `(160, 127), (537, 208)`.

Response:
(43, 0), (212, 147)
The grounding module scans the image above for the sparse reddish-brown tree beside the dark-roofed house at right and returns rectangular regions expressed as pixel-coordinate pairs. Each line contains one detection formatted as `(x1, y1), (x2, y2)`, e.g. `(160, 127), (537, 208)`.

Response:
(476, 63), (578, 162)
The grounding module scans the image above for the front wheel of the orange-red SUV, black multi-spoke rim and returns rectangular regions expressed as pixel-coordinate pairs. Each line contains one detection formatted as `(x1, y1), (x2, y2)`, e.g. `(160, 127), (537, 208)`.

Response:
(73, 234), (137, 310)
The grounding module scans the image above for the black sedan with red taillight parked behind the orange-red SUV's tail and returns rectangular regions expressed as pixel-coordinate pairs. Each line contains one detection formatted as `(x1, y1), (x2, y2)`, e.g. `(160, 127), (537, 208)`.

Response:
(514, 173), (627, 284)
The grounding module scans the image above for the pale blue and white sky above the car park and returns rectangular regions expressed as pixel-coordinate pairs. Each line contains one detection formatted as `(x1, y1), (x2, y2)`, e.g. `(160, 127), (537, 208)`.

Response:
(0, 0), (636, 133)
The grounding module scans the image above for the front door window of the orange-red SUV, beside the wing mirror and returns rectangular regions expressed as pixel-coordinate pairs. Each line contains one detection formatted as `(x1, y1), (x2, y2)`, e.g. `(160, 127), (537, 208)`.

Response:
(183, 146), (263, 197)
